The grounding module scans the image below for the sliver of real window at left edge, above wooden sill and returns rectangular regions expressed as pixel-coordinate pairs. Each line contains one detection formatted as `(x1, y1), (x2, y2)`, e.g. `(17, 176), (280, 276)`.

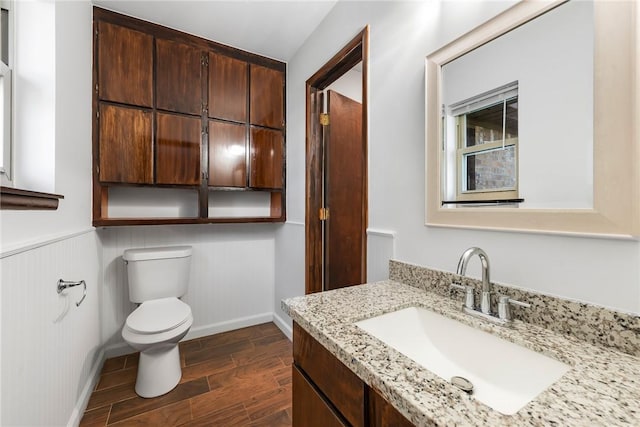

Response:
(0, 1), (13, 185)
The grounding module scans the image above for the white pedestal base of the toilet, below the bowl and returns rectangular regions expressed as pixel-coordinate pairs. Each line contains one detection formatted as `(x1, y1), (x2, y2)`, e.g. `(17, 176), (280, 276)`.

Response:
(136, 343), (182, 398)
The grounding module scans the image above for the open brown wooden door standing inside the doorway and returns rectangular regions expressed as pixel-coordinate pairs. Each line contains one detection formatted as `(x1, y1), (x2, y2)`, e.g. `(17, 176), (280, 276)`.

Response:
(324, 90), (366, 290)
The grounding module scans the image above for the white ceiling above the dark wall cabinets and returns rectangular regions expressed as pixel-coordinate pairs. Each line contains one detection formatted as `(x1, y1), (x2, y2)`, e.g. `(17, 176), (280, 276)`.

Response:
(93, 0), (338, 62)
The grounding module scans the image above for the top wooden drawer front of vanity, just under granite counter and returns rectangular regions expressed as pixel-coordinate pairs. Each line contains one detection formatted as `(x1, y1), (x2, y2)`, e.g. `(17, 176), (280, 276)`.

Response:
(293, 322), (365, 427)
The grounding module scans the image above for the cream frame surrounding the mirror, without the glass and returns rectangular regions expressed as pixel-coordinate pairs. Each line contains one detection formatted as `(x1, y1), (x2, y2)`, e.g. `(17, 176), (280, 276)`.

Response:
(425, 0), (640, 238)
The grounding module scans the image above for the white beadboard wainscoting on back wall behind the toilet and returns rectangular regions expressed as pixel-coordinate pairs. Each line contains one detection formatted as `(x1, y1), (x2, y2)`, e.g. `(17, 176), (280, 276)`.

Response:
(98, 224), (275, 357)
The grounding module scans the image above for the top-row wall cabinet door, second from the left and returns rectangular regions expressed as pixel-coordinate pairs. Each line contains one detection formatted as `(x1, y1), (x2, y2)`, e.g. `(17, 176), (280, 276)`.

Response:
(156, 39), (202, 115)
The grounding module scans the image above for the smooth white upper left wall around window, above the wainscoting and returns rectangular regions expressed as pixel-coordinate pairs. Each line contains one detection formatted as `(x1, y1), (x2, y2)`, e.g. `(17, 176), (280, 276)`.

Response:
(0, 1), (92, 251)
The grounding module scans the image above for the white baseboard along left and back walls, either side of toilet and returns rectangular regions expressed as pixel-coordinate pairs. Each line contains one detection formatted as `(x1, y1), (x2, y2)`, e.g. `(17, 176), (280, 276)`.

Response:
(67, 313), (282, 427)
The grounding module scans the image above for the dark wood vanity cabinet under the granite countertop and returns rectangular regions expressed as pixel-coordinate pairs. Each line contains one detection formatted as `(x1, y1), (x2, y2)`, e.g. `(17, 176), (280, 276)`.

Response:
(292, 322), (413, 427)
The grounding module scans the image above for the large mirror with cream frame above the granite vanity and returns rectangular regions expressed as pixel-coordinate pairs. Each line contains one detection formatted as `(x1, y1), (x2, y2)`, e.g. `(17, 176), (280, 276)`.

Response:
(425, 1), (640, 237)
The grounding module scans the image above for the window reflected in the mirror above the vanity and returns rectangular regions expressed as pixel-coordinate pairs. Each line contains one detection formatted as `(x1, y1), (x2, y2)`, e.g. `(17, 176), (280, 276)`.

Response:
(448, 82), (518, 206)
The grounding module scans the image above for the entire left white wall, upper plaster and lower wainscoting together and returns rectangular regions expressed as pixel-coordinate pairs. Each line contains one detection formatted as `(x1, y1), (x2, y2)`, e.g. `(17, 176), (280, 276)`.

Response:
(0, 1), (102, 425)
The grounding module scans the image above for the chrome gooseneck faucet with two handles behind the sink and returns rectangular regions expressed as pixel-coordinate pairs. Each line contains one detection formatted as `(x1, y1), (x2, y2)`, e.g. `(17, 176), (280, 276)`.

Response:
(451, 247), (531, 324)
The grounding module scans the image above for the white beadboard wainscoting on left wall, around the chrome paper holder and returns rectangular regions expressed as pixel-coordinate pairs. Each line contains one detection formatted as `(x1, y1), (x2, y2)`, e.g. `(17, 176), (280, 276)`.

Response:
(0, 230), (102, 426)
